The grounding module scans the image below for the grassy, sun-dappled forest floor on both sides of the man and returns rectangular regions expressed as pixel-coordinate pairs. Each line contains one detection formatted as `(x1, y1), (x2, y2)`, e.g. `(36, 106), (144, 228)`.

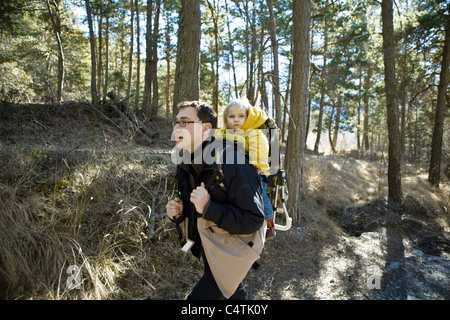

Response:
(0, 103), (450, 300)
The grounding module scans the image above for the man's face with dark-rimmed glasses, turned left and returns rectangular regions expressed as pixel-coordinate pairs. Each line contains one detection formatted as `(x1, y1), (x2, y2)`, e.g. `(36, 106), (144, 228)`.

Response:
(173, 107), (206, 153)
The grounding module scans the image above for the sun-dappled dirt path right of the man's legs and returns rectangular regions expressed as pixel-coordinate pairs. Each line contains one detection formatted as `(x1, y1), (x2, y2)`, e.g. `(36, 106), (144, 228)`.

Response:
(247, 198), (450, 300)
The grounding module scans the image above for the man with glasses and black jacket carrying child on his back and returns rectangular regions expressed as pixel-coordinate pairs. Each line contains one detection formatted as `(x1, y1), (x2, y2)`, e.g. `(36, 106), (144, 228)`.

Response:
(166, 101), (266, 300)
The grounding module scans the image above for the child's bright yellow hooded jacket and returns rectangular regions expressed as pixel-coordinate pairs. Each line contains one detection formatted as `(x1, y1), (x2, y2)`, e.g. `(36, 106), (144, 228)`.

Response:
(214, 107), (270, 175)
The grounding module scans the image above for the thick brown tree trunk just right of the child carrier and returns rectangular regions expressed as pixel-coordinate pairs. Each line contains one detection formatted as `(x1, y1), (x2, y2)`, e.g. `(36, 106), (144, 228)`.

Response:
(286, 0), (311, 223)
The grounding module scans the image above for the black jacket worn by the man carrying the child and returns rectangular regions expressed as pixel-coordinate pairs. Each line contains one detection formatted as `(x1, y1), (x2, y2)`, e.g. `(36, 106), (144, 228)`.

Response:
(172, 142), (264, 257)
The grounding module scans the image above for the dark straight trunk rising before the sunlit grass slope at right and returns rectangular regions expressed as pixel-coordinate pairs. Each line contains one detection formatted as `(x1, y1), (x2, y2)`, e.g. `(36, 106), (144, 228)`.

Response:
(381, 0), (403, 204)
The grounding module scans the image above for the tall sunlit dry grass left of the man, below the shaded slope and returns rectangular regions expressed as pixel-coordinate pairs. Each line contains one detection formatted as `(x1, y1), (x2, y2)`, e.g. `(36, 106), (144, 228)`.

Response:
(0, 143), (200, 299)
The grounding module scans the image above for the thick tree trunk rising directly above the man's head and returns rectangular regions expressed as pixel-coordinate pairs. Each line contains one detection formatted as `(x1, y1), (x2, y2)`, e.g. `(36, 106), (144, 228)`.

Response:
(173, 0), (201, 114)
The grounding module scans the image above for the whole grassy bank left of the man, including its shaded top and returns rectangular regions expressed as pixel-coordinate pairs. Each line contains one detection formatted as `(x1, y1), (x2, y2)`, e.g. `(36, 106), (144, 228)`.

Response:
(0, 103), (201, 299)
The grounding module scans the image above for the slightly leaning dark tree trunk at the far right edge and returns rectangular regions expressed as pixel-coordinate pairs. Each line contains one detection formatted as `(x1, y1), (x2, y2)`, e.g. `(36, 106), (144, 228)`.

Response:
(428, 10), (450, 187)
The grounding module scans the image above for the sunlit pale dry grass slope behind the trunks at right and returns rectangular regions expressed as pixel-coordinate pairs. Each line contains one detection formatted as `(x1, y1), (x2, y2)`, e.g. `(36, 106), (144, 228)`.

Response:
(303, 155), (450, 216)
